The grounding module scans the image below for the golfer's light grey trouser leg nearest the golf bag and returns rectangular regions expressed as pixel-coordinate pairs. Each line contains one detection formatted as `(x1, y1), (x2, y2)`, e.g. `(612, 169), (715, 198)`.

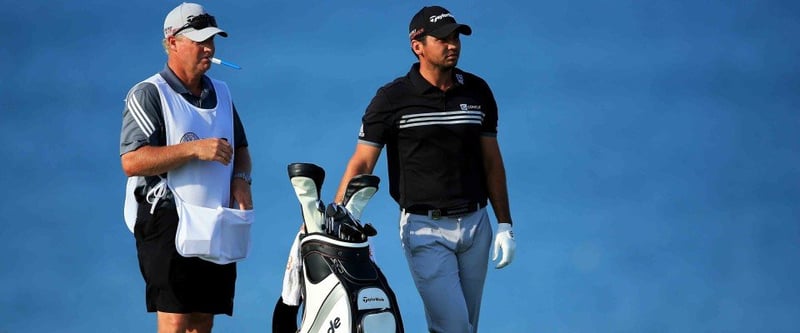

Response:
(400, 214), (469, 333)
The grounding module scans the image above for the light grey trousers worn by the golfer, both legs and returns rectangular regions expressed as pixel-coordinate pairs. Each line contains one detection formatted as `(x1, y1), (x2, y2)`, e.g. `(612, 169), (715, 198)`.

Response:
(400, 208), (492, 333)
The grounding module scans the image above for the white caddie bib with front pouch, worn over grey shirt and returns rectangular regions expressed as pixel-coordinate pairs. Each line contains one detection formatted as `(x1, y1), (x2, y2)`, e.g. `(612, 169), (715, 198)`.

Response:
(125, 74), (254, 264)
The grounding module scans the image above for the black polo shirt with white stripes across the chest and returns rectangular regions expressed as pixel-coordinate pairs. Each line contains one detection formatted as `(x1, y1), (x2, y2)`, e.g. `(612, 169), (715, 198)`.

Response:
(359, 63), (497, 208)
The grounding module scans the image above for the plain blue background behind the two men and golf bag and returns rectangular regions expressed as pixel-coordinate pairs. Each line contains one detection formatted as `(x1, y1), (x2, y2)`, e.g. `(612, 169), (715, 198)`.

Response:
(0, 0), (800, 333)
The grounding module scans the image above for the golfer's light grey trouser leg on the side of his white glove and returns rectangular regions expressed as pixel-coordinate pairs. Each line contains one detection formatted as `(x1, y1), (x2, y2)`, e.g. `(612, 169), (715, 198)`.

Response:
(458, 209), (492, 333)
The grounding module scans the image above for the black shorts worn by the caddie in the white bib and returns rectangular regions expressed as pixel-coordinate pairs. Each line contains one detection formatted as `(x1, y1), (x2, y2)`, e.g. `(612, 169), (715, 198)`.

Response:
(134, 204), (236, 316)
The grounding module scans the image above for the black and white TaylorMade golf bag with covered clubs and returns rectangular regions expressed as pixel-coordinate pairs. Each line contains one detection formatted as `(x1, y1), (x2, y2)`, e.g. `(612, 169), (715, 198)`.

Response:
(272, 163), (403, 333)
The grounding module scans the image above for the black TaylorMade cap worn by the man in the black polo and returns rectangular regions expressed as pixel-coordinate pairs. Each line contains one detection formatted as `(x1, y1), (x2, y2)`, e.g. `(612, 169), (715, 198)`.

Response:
(408, 6), (472, 39)
